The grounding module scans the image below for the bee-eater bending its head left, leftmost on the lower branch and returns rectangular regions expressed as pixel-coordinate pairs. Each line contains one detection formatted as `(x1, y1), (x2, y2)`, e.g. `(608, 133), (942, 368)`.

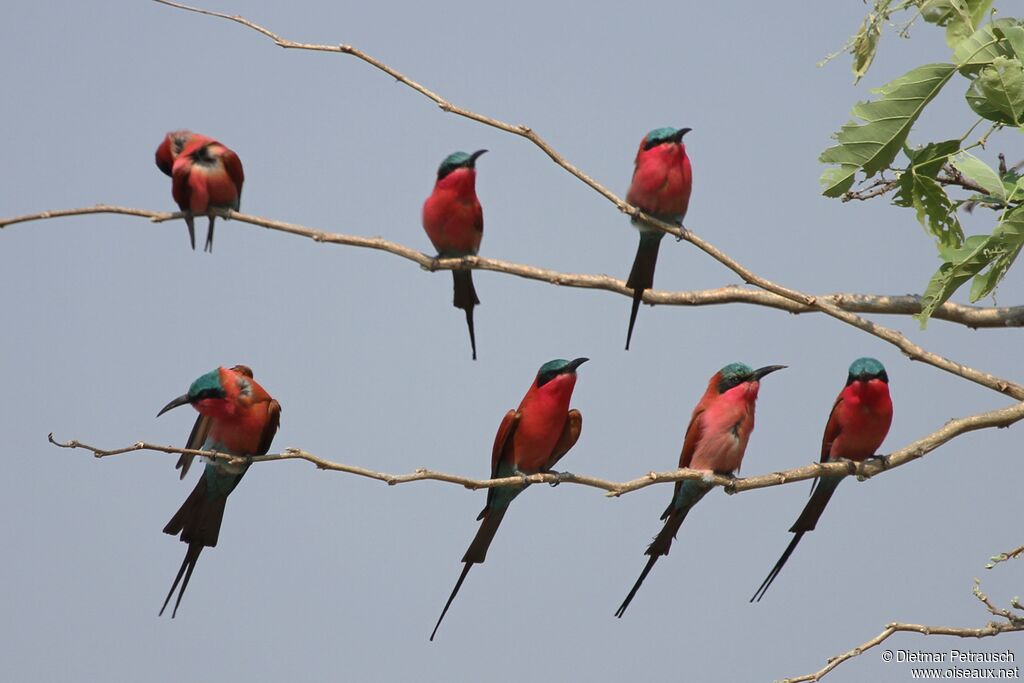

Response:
(158, 366), (281, 618)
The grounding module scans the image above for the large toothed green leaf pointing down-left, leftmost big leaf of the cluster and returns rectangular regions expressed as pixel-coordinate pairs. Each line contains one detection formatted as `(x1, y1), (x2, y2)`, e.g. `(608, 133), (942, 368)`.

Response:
(818, 63), (956, 197)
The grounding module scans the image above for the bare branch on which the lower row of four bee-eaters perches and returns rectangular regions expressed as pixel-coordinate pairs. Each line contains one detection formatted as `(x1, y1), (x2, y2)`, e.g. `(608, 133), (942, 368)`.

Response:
(48, 395), (1024, 497)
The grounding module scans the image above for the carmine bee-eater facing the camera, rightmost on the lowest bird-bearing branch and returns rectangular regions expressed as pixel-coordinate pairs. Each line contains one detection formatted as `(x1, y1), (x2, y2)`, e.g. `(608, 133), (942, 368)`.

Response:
(751, 358), (893, 602)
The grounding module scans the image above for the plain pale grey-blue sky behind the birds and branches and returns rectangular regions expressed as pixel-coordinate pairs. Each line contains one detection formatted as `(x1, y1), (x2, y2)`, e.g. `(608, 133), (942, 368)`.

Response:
(0, 0), (1022, 683)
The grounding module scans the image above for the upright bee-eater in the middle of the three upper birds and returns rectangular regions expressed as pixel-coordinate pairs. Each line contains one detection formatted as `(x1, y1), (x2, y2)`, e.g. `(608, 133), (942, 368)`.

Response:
(423, 150), (486, 360)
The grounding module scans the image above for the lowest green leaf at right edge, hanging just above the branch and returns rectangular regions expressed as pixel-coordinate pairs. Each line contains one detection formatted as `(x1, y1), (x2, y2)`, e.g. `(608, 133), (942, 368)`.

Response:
(915, 207), (1024, 328)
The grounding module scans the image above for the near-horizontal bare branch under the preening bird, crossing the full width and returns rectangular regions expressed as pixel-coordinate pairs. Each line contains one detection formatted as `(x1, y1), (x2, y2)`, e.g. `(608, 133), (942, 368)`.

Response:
(6, 204), (1024, 330)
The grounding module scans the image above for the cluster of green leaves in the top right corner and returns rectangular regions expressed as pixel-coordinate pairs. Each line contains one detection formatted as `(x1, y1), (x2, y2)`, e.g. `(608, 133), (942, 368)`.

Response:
(819, 0), (1024, 326)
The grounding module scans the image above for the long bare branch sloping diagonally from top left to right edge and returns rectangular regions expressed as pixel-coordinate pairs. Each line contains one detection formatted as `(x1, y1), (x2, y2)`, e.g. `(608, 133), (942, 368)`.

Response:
(148, 0), (1024, 399)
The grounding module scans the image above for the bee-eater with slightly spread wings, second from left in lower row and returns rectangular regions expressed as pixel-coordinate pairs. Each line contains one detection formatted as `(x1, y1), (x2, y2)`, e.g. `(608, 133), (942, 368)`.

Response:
(430, 358), (587, 640)
